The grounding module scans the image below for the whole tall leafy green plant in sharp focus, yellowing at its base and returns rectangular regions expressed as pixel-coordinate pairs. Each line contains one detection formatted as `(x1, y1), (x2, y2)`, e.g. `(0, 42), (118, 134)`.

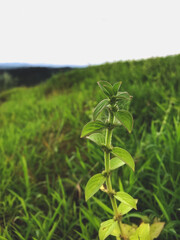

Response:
(81, 81), (168, 240)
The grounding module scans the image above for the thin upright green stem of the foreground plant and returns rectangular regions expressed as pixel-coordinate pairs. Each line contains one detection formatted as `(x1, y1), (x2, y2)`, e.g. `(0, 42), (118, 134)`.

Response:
(104, 112), (124, 239)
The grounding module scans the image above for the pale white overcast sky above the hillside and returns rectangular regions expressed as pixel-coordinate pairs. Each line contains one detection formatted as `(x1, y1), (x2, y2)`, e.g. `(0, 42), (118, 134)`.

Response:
(0, 0), (180, 65)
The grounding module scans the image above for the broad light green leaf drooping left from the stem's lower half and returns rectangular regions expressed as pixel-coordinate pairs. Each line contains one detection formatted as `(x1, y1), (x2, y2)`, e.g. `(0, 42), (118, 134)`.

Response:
(85, 173), (106, 201)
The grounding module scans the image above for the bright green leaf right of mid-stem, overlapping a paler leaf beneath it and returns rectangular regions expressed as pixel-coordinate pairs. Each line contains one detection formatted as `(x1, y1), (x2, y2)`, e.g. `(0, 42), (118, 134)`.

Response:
(112, 147), (135, 171)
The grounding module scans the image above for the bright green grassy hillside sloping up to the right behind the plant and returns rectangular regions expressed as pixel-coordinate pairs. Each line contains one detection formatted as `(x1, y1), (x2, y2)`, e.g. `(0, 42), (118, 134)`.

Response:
(0, 55), (180, 240)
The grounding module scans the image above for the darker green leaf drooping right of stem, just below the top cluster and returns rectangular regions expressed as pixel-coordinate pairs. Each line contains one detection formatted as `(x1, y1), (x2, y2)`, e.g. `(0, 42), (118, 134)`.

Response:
(115, 110), (133, 133)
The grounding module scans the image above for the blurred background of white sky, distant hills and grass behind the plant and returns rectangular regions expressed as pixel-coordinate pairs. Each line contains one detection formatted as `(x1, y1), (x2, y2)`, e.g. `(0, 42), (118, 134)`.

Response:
(0, 0), (180, 240)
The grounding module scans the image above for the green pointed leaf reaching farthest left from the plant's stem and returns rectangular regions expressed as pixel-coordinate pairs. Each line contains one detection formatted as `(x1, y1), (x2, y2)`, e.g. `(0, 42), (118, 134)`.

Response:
(81, 120), (106, 138)
